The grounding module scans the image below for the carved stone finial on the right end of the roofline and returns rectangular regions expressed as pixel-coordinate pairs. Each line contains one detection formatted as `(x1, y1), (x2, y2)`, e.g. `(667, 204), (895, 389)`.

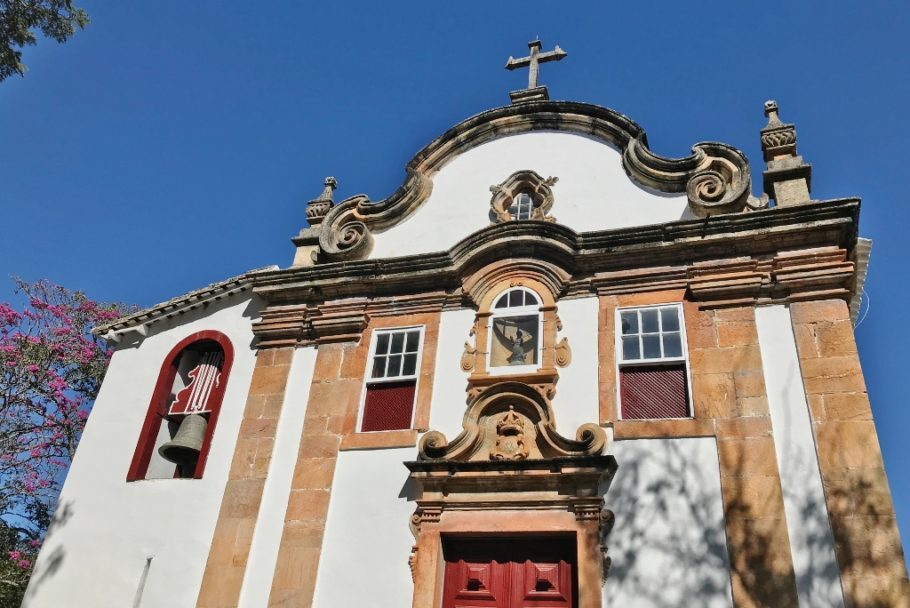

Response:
(761, 99), (812, 207)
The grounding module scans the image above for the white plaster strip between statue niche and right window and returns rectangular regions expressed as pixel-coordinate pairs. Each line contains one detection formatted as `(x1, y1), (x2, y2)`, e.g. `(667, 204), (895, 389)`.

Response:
(553, 298), (599, 439)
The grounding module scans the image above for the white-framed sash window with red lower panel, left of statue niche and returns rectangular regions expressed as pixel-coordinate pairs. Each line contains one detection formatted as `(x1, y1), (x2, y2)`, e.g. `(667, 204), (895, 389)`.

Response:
(359, 327), (423, 432)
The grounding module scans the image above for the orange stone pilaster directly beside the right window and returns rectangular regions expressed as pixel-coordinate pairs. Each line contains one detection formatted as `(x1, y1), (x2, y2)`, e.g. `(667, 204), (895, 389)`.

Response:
(686, 305), (798, 608)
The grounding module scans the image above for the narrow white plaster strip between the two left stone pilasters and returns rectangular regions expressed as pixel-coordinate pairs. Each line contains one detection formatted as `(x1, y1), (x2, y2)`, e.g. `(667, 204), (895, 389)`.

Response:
(239, 347), (316, 608)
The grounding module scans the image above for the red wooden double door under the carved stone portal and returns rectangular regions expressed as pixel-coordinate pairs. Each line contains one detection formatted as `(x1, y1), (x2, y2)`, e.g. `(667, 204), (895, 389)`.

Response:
(442, 536), (578, 608)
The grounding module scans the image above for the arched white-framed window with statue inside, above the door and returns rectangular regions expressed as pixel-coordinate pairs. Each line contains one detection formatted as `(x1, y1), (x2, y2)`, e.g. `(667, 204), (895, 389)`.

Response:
(488, 287), (543, 374)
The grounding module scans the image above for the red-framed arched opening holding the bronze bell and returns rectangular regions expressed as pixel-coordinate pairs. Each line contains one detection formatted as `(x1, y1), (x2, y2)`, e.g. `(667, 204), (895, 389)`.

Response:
(126, 331), (234, 481)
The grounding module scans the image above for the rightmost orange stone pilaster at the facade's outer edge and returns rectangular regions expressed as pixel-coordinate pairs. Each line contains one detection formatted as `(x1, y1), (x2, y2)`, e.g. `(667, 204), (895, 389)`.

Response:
(790, 300), (910, 607)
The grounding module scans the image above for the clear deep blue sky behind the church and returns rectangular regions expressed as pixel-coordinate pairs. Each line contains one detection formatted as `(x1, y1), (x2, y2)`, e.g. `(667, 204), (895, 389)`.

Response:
(0, 0), (910, 564)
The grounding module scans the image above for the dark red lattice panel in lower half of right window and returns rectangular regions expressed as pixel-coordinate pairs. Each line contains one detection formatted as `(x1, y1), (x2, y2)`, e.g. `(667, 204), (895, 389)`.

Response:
(619, 363), (689, 420)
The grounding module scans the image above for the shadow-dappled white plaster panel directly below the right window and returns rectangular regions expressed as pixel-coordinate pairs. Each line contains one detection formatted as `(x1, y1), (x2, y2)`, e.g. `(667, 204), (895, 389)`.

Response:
(604, 437), (733, 608)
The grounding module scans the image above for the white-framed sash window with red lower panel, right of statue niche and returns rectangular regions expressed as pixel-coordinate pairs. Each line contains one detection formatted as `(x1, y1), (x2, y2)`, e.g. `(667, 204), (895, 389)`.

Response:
(616, 304), (690, 419)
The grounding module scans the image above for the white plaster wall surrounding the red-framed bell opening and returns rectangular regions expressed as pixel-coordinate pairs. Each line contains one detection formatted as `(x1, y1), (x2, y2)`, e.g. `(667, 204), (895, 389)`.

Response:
(23, 296), (260, 608)
